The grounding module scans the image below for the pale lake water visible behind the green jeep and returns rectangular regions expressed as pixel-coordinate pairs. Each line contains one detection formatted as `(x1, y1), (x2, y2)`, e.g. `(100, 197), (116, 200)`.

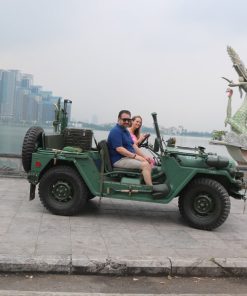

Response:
(0, 125), (230, 157)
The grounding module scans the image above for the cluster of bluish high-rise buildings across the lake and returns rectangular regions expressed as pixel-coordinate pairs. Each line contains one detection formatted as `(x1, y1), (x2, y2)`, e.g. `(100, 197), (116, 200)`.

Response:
(0, 69), (66, 124)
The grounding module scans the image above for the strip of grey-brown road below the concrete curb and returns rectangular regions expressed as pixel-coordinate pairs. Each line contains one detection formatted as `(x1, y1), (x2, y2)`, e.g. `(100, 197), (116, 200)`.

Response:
(0, 274), (247, 296)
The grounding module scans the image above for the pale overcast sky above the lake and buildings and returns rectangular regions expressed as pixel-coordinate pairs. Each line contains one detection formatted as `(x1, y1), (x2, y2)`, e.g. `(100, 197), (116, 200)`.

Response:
(0, 0), (247, 131)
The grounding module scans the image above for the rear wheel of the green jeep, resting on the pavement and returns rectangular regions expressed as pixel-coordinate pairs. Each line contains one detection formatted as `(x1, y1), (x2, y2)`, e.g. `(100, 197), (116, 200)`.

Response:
(39, 166), (88, 216)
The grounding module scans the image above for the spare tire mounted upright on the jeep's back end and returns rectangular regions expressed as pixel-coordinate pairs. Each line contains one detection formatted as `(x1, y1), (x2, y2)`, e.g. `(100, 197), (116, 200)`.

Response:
(22, 126), (44, 172)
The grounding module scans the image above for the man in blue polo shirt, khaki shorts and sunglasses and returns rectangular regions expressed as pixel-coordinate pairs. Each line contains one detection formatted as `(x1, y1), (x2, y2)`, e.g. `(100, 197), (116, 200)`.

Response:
(107, 110), (152, 186)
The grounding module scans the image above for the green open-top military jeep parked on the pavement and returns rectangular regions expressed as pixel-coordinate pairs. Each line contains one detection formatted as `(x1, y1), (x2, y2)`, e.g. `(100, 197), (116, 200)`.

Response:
(22, 100), (245, 230)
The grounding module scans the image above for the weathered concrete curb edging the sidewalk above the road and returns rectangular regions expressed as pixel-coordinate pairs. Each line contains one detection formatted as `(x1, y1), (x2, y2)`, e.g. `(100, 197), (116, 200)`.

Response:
(0, 255), (247, 277)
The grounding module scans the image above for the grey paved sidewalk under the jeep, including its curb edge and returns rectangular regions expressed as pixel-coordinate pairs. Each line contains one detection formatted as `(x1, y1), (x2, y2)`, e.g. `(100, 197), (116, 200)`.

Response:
(0, 178), (247, 276)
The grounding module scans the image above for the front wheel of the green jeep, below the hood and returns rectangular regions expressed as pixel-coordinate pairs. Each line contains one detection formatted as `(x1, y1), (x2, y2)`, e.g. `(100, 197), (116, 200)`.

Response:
(178, 178), (231, 230)
